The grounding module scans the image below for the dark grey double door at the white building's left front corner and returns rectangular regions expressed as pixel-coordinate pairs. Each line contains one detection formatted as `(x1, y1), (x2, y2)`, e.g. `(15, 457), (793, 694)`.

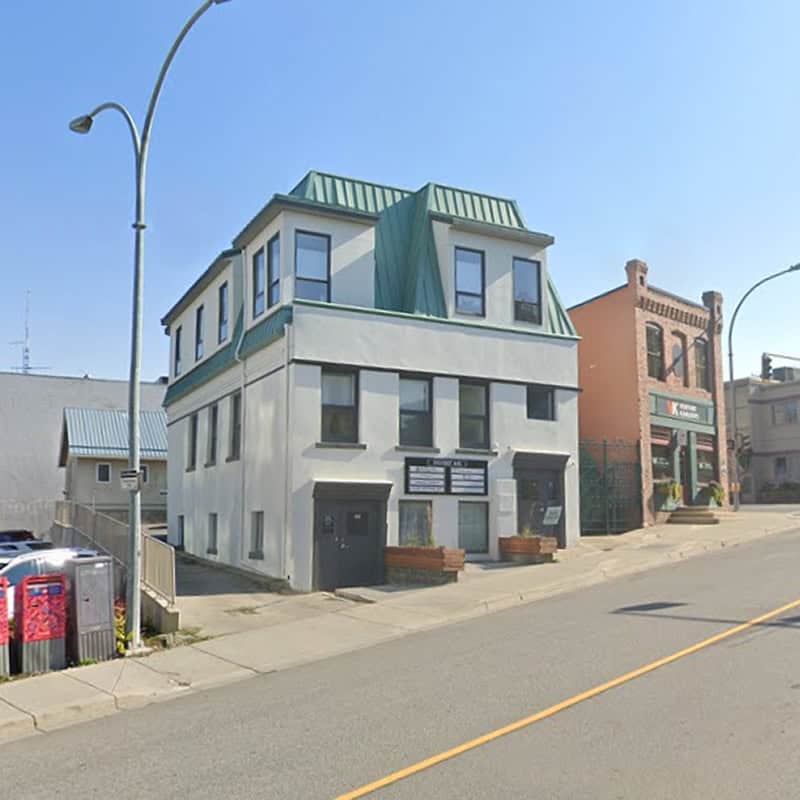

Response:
(314, 500), (383, 591)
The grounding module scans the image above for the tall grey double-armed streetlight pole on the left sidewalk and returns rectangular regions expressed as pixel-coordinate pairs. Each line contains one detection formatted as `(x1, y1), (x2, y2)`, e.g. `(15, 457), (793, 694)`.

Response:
(69, 0), (228, 652)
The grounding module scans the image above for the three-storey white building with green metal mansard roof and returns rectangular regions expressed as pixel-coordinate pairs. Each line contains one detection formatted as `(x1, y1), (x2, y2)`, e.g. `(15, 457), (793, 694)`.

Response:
(162, 172), (580, 590)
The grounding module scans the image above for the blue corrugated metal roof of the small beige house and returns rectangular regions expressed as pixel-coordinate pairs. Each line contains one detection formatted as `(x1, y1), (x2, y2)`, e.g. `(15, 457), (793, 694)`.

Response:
(61, 408), (167, 460)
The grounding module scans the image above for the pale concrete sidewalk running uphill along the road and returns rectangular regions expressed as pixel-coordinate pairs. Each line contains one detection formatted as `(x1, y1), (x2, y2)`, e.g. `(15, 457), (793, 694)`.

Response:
(0, 512), (800, 742)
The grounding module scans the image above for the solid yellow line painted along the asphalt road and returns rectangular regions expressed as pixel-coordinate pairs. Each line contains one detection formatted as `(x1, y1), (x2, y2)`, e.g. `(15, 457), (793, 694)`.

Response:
(335, 599), (800, 800)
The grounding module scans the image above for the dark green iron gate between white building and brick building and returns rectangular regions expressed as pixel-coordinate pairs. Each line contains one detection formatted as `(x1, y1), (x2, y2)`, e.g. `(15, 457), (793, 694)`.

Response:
(580, 441), (642, 534)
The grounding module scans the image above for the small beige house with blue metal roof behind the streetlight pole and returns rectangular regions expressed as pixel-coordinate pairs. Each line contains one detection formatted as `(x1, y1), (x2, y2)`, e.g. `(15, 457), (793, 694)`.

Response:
(58, 408), (167, 523)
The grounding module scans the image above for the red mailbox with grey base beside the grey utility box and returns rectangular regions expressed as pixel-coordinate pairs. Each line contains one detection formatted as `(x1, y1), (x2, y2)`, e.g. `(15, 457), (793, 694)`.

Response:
(14, 574), (67, 673)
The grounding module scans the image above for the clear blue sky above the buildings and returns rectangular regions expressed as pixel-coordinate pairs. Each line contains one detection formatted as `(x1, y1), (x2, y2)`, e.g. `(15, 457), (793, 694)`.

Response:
(0, 0), (800, 378)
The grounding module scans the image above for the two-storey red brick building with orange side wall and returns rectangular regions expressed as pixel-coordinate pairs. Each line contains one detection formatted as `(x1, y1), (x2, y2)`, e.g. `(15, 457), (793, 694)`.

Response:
(569, 260), (728, 525)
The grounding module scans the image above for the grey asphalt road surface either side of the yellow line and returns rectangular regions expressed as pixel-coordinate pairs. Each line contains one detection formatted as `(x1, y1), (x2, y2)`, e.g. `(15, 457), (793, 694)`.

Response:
(6, 530), (800, 800)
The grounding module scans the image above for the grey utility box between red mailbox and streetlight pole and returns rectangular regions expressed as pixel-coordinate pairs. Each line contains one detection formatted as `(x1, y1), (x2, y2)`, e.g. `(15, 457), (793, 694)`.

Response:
(64, 556), (116, 664)
